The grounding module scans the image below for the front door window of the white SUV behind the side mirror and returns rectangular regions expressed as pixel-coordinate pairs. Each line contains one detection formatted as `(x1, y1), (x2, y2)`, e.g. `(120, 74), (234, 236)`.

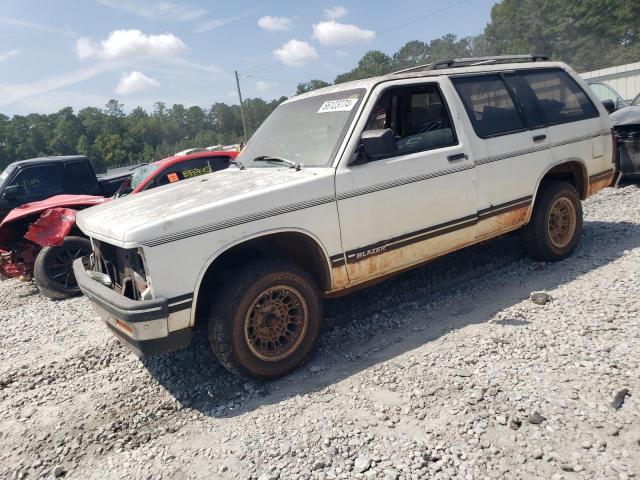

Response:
(365, 83), (458, 155)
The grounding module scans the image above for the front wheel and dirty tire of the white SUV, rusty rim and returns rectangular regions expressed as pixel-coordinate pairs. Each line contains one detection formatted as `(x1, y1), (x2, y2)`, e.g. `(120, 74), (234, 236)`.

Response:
(209, 260), (322, 380)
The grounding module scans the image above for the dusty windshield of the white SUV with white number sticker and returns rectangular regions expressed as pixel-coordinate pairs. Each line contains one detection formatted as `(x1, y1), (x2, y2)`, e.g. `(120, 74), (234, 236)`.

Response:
(237, 89), (364, 168)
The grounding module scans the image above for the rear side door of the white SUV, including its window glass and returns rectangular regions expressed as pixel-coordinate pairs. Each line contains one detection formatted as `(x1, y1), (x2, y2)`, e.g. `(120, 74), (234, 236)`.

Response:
(451, 72), (551, 238)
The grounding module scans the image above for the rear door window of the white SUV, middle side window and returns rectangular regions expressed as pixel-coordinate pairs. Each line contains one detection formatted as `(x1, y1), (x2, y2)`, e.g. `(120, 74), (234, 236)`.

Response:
(451, 75), (525, 138)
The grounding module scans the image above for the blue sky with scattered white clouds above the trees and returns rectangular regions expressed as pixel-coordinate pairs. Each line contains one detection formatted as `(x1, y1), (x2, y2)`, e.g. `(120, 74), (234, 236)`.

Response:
(0, 0), (495, 115)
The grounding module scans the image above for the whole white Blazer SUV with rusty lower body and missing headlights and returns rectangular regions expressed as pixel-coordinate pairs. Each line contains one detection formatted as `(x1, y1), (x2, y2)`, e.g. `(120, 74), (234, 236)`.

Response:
(74, 56), (616, 378)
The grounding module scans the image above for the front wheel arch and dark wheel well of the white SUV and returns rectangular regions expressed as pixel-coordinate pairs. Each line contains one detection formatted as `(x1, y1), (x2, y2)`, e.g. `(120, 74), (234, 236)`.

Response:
(190, 228), (333, 326)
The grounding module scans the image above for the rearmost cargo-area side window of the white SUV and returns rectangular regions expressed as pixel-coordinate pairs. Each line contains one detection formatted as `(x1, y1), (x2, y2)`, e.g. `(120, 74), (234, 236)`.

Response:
(519, 70), (598, 125)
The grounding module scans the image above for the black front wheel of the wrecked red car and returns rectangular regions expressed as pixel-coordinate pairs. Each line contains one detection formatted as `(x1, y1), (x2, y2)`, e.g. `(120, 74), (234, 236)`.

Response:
(33, 237), (91, 300)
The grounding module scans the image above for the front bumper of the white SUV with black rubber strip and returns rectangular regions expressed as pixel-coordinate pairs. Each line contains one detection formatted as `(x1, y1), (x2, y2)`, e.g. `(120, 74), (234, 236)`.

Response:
(73, 257), (191, 356)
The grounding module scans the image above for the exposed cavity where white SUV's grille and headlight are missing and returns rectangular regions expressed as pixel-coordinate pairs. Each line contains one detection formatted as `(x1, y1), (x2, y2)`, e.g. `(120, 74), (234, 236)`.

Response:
(87, 239), (152, 300)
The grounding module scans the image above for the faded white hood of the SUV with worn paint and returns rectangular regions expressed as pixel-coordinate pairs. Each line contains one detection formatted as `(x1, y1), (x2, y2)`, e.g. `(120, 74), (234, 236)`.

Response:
(77, 168), (334, 246)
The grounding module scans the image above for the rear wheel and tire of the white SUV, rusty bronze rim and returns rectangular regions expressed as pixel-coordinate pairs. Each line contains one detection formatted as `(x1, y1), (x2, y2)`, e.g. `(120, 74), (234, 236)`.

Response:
(522, 181), (582, 262)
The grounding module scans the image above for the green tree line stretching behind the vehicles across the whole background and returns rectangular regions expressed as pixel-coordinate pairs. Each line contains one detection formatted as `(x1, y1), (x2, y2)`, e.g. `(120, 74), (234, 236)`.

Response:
(0, 0), (640, 171)
